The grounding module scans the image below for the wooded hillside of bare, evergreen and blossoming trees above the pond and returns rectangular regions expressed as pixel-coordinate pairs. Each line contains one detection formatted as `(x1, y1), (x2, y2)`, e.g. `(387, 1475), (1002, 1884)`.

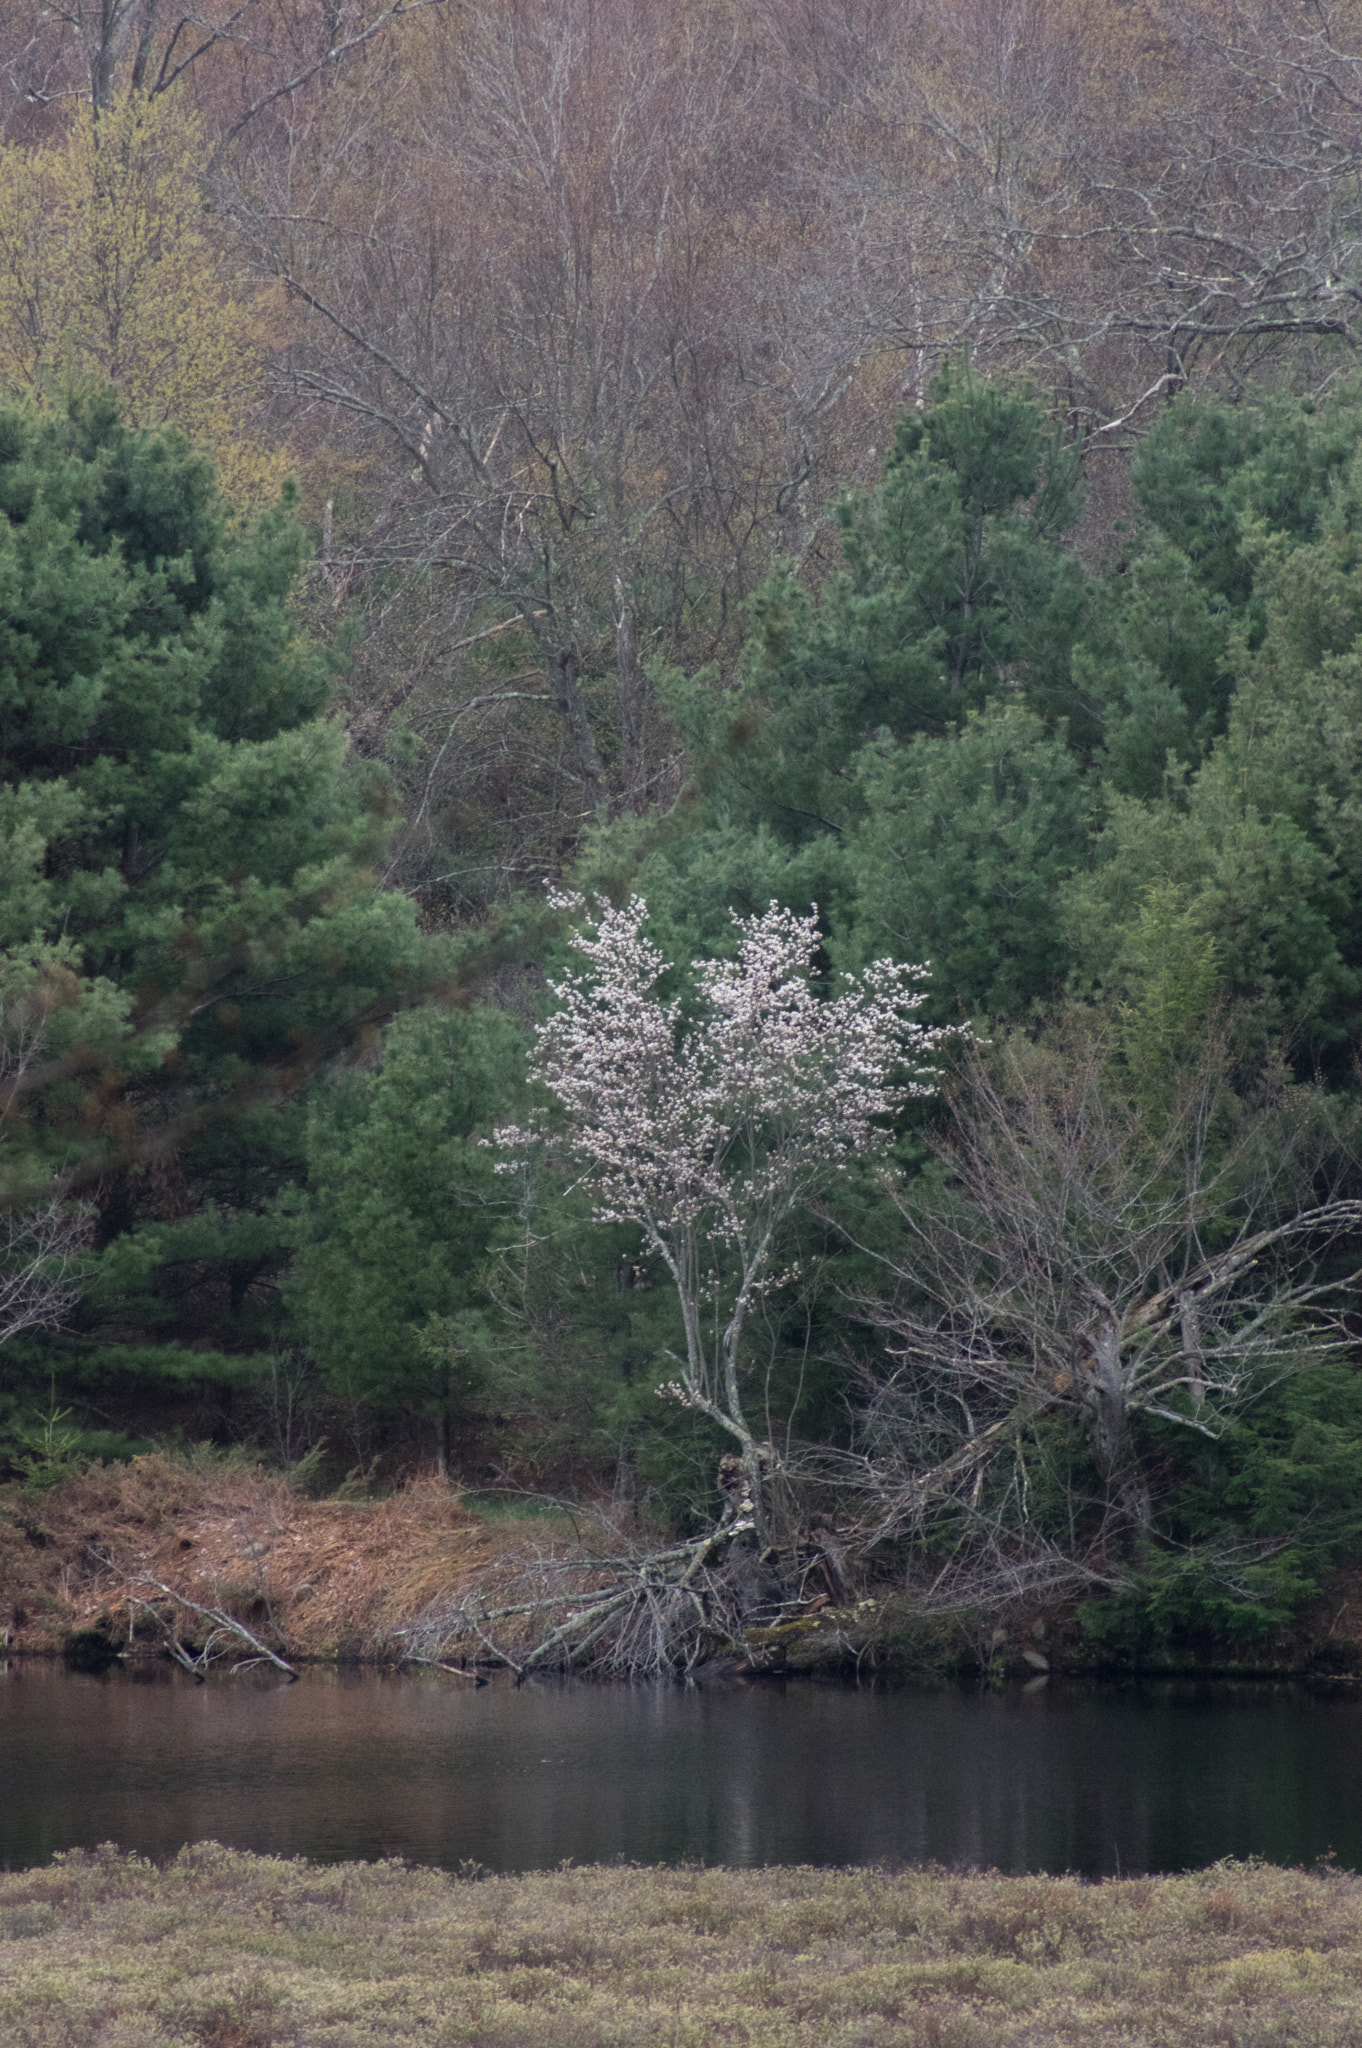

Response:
(0, 0), (1362, 1671)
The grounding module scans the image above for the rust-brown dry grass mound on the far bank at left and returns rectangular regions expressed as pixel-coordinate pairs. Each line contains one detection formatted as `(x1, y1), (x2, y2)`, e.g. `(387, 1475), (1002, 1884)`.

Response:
(0, 1452), (532, 1657)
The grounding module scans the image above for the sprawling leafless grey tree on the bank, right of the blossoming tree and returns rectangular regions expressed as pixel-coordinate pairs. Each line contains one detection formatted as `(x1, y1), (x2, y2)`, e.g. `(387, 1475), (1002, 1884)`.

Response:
(860, 1032), (1362, 1561)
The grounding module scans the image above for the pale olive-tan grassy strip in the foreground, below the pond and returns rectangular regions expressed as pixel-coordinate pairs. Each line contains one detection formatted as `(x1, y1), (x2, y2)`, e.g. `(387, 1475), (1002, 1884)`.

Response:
(0, 1843), (1362, 2048)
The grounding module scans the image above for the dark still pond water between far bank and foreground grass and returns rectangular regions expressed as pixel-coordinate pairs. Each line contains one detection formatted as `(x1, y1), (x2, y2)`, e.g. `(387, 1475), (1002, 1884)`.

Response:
(0, 1663), (1362, 1876)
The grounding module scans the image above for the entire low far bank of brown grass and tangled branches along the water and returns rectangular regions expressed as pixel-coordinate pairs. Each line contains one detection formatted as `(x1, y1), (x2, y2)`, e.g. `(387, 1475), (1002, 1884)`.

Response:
(0, 1448), (1362, 1683)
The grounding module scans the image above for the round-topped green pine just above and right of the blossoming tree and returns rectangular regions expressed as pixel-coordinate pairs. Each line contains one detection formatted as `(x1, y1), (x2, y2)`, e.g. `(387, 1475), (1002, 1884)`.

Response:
(692, 371), (1086, 844)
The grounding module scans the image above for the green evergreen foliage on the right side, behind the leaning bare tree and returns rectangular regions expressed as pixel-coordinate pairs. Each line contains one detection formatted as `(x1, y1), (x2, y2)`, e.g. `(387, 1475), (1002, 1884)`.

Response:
(557, 377), (1362, 1655)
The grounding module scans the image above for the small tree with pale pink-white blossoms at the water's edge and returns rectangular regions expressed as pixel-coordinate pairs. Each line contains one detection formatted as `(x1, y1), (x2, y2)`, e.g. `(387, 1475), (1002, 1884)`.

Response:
(496, 895), (944, 1526)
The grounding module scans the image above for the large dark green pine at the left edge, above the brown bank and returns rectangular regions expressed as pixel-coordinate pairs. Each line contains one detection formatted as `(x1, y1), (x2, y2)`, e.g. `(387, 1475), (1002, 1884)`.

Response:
(0, 397), (428, 1458)
